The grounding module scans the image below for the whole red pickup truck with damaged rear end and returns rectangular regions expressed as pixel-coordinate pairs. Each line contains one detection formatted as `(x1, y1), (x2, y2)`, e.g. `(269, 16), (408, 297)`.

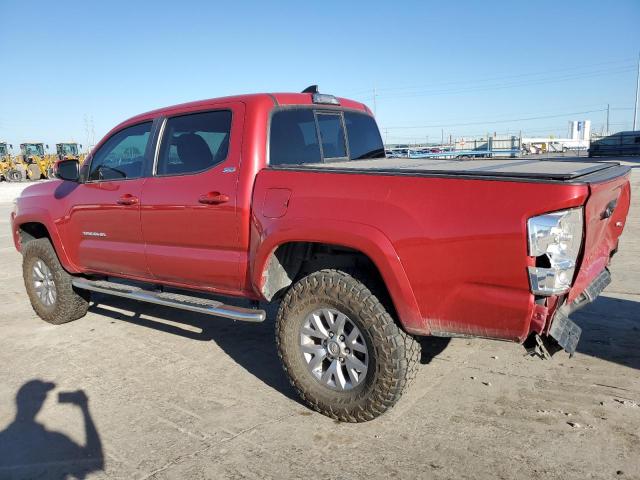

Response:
(11, 88), (630, 422)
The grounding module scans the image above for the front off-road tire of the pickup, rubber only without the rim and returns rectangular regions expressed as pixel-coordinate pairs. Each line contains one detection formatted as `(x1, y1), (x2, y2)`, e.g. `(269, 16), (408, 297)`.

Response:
(22, 238), (90, 325)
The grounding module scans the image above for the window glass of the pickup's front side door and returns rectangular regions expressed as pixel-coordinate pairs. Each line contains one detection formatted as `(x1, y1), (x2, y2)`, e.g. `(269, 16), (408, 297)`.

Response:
(88, 122), (152, 181)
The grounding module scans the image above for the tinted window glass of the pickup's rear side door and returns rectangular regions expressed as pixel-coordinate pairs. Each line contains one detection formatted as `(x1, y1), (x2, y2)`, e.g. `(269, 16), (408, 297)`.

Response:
(156, 110), (231, 175)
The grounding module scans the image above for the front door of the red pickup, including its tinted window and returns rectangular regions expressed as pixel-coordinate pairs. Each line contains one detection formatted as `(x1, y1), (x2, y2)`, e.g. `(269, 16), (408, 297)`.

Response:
(62, 121), (153, 276)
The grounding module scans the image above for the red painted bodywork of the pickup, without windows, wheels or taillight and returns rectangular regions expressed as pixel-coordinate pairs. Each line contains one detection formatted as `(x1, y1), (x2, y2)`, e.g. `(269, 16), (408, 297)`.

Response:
(12, 93), (629, 341)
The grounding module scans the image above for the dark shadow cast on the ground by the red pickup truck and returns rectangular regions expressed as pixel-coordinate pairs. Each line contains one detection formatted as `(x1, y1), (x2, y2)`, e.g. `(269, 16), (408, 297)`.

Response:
(91, 295), (640, 403)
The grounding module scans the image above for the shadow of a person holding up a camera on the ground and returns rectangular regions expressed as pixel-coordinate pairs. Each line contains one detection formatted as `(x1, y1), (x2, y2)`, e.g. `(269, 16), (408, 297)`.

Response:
(0, 380), (104, 479)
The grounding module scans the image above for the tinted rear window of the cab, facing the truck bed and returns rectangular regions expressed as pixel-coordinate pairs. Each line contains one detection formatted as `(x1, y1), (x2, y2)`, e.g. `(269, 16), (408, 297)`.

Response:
(269, 108), (385, 165)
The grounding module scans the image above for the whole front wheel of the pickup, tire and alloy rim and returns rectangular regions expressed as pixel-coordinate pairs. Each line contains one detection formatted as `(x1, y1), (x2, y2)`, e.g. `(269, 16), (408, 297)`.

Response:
(22, 238), (89, 325)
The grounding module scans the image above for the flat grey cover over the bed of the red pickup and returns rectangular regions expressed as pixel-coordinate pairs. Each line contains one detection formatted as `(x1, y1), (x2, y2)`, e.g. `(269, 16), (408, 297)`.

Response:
(296, 158), (628, 183)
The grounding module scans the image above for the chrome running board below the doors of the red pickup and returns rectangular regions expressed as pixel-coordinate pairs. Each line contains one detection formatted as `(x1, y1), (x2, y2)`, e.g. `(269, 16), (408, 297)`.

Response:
(72, 278), (267, 322)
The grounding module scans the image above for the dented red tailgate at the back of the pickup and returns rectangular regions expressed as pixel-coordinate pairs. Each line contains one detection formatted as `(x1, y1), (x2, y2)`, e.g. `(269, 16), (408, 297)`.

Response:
(567, 173), (631, 303)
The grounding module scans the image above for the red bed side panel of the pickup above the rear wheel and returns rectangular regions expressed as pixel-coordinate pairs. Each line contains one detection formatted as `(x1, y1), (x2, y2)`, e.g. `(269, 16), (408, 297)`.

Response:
(252, 169), (588, 341)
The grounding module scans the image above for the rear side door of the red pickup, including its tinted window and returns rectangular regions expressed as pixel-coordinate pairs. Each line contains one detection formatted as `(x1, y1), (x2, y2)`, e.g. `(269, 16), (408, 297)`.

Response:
(140, 103), (244, 293)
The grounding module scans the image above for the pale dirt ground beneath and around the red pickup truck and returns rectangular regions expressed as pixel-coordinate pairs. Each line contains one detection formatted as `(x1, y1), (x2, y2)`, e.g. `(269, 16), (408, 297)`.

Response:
(0, 161), (640, 479)
